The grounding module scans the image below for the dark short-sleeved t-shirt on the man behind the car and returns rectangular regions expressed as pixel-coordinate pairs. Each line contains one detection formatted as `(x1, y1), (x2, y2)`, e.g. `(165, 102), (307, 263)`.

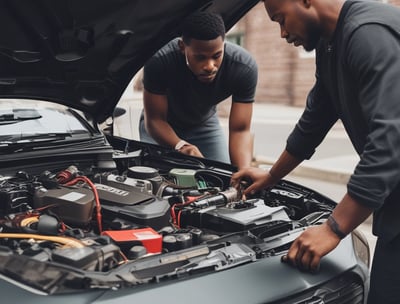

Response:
(143, 38), (258, 129)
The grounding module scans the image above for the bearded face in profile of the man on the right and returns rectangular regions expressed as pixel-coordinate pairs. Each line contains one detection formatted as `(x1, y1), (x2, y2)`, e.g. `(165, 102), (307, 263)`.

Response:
(264, 0), (321, 51)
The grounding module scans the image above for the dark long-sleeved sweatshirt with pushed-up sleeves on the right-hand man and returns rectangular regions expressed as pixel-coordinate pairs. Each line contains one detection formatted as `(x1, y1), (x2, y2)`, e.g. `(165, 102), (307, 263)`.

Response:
(286, 0), (400, 241)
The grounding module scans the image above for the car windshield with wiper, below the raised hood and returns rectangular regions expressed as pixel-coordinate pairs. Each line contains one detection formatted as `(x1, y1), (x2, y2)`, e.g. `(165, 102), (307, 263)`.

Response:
(0, 100), (89, 144)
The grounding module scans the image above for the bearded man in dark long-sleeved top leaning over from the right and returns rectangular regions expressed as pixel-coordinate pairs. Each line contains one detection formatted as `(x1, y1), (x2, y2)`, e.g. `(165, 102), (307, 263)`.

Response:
(232, 0), (400, 304)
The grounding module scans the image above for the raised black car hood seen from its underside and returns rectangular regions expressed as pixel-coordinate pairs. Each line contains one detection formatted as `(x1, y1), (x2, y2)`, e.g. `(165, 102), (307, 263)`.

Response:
(0, 0), (259, 122)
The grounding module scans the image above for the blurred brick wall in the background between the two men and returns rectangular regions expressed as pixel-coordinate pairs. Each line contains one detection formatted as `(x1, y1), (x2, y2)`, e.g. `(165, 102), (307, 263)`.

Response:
(238, 0), (400, 106)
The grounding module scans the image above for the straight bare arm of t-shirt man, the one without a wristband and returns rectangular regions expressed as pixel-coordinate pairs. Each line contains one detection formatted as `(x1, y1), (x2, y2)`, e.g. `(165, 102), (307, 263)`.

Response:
(229, 102), (253, 169)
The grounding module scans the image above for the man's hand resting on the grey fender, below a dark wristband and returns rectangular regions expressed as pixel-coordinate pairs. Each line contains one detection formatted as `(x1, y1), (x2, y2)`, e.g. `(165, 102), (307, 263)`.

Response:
(282, 223), (340, 272)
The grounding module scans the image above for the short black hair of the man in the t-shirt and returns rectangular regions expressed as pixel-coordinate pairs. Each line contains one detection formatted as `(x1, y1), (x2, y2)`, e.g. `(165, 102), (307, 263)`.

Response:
(182, 11), (225, 44)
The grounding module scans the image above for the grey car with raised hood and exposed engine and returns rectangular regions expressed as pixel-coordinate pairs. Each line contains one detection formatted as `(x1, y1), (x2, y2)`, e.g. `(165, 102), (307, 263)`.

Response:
(0, 0), (369, 304)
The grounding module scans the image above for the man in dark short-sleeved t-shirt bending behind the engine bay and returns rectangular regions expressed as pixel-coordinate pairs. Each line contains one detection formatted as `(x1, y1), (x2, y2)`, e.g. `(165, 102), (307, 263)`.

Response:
(139, 12), (257, 168)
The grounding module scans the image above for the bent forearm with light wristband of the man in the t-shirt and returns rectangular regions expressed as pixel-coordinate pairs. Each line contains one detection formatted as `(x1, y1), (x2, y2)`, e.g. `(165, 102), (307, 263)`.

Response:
(143, 89), (203, 157)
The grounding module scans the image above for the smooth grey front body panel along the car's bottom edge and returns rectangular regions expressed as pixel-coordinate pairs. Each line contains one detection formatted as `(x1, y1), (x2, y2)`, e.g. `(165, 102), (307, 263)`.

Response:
(0, 237), (367, 304)
